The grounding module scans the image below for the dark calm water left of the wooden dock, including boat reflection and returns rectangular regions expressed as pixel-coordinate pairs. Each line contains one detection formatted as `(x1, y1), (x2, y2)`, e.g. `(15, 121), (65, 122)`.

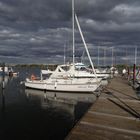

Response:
(0, 69), (96, 140)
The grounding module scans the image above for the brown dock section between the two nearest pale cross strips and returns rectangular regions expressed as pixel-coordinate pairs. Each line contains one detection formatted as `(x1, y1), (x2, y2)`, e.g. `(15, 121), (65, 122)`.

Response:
(81, 112), (140, 131)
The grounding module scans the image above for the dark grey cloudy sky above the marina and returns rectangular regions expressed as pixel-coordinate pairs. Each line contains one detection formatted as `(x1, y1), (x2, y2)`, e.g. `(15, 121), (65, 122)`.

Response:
(0, 0), (140, 64)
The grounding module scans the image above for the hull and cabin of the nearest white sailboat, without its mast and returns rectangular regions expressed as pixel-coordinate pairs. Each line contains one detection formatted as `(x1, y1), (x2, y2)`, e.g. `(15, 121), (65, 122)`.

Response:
(25, 65), (101, 93)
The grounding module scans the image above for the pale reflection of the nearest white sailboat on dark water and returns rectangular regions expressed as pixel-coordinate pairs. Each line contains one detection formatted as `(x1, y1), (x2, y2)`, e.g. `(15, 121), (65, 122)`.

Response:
(25, 89), (96, 117)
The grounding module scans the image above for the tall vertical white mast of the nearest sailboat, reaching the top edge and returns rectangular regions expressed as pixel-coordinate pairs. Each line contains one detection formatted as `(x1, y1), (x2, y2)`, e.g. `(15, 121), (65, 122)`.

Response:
(72, 0), (75, 64)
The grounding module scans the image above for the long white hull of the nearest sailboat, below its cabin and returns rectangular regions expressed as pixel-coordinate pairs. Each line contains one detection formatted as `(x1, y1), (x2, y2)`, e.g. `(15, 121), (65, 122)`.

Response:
(25, 80), (99, 93)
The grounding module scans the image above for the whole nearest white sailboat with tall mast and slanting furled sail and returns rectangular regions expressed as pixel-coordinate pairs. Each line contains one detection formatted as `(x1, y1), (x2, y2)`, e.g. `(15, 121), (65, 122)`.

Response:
(25, 0), (101, 93)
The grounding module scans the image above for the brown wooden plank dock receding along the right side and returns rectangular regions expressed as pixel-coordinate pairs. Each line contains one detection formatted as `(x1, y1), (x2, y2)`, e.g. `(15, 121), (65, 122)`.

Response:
(66, 77), (140, 140)
